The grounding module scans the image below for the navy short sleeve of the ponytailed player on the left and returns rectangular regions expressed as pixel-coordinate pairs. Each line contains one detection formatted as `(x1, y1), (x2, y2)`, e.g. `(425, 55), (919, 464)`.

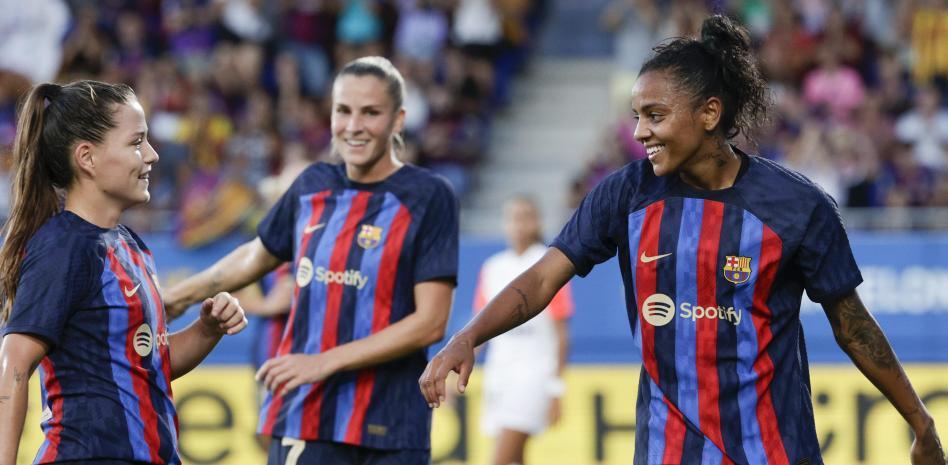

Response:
(3, 236), (101, 346)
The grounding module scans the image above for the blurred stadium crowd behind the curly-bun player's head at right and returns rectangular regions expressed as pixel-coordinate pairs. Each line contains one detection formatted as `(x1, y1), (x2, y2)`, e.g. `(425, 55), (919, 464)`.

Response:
(573, 0), (948, 225)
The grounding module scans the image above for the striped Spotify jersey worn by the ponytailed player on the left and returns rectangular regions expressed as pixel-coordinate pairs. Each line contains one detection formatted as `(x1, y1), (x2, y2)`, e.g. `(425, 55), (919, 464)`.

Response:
(3, 211), (181, 464)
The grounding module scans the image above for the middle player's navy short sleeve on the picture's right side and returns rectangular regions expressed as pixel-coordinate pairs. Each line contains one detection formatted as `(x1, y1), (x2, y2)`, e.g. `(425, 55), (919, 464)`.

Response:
(414, 179), (459, 284)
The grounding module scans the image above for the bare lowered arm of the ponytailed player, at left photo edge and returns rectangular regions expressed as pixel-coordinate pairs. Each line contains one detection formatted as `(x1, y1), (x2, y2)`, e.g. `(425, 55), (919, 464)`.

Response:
(0, 333), (49, 465)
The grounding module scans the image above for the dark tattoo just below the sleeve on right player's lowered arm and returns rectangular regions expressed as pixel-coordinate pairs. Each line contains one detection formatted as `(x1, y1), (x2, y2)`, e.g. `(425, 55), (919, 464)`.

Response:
(829, 295), (901, 371)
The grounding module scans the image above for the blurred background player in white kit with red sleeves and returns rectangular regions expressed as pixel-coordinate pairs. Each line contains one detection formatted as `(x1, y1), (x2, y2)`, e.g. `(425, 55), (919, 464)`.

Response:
(474, 197), (573, 465)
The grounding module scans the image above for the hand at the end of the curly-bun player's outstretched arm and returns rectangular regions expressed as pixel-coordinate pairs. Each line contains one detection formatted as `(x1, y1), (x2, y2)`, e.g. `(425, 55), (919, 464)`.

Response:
(418, 333), (474, 408)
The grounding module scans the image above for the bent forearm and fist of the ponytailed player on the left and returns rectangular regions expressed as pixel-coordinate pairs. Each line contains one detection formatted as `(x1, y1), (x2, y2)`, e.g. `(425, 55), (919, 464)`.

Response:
(168, 292), (247, 379)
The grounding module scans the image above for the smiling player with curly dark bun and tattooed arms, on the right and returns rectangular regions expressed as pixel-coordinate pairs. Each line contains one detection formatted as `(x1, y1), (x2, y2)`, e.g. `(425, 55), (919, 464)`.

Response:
(419, 16), (945, 465)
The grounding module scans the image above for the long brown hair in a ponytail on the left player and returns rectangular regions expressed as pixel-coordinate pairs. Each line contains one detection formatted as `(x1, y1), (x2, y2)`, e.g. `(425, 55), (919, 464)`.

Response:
(0, 81), (134, 324)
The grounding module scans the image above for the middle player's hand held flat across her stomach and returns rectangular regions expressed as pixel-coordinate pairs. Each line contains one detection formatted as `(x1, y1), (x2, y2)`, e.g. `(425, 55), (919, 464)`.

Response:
(255, 352), (336, 396)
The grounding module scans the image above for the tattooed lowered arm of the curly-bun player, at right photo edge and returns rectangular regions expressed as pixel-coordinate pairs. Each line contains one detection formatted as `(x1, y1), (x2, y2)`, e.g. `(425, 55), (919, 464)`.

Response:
(823, 291), (945, 465)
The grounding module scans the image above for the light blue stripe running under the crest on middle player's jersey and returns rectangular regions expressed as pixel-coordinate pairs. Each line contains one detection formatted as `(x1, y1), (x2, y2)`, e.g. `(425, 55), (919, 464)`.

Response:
(333, 192), (401, 441)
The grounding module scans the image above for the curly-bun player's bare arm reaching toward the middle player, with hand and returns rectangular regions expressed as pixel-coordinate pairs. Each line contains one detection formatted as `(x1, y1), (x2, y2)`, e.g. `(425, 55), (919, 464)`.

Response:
(418, 247), (576, 407)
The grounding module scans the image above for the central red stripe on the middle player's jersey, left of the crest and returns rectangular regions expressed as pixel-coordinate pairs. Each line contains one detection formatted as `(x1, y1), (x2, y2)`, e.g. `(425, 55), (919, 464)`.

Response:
(300, 192), (372, 439)
